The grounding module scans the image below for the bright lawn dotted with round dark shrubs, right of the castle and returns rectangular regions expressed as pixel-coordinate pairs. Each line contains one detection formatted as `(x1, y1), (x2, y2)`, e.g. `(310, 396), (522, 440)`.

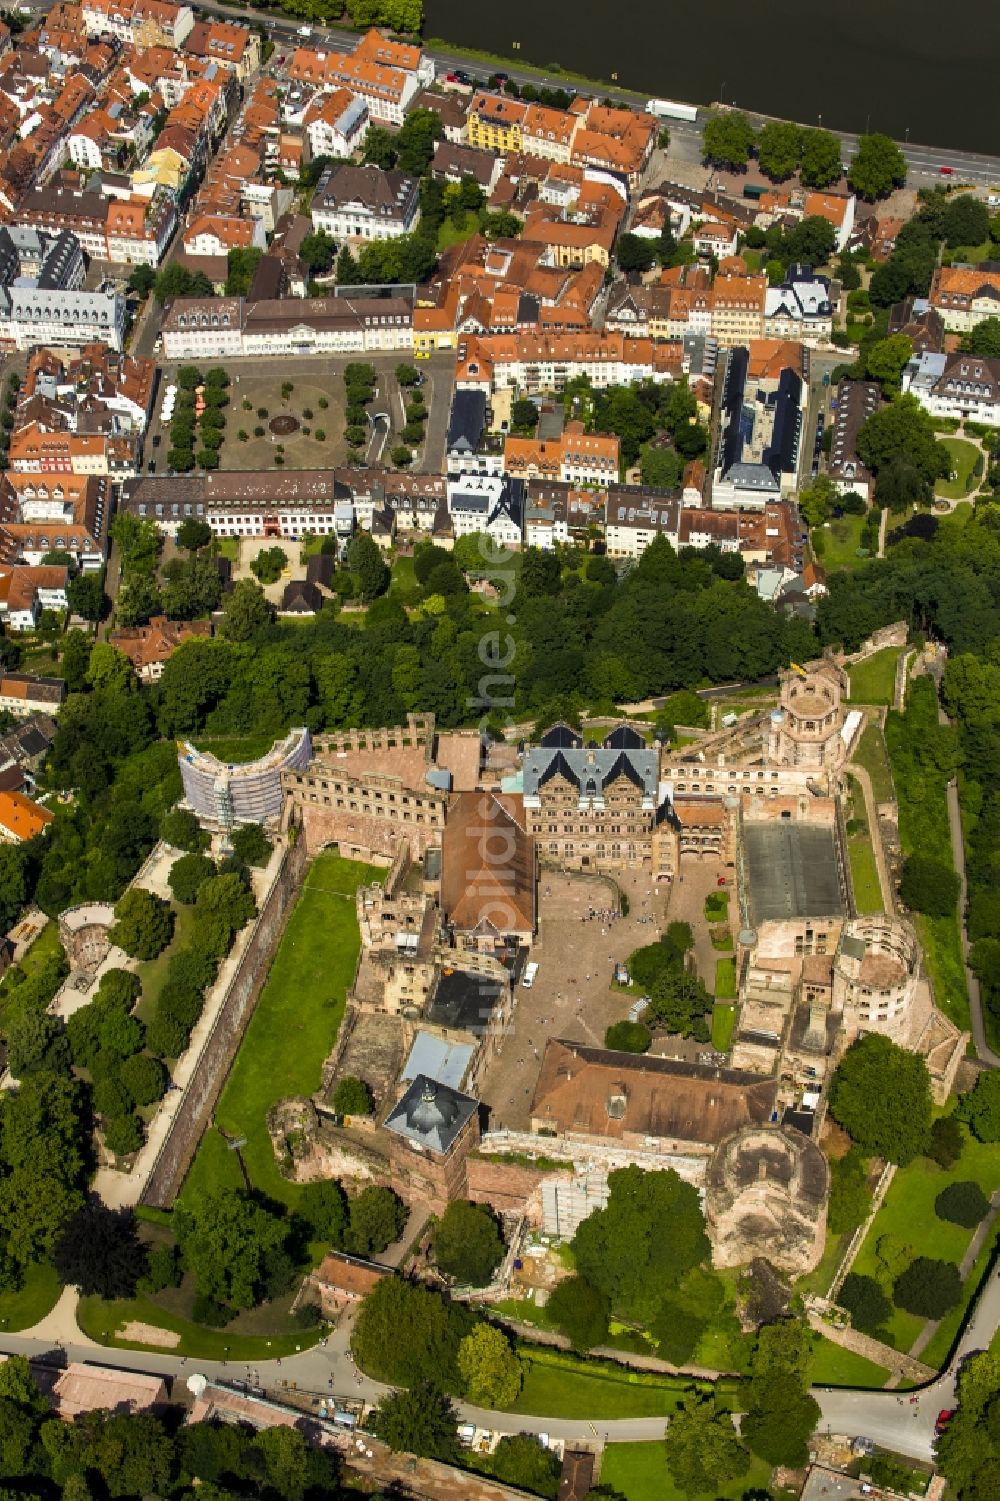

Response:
(851, 1136), (1000, 1363)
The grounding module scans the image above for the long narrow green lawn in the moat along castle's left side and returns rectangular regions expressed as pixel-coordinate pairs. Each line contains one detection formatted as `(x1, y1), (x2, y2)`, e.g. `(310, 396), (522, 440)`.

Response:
(183, 853), (384, 1204)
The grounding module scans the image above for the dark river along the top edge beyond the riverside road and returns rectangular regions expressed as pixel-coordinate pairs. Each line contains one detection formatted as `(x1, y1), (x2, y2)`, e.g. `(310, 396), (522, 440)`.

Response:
(423, 0), (1000, 155)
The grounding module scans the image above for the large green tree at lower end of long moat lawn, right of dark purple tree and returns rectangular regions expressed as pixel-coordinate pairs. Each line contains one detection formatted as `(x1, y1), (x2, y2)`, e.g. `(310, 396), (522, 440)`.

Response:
(177, 1189), (288, 1309)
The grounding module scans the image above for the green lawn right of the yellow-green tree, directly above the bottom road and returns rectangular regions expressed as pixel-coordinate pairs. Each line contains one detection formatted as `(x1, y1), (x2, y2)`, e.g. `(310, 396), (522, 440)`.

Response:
(509, 1349), (688, 1421)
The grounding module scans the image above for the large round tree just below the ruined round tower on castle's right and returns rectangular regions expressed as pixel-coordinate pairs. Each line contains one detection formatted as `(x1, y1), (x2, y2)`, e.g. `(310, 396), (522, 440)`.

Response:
(830, 1033), (931, 1166)
